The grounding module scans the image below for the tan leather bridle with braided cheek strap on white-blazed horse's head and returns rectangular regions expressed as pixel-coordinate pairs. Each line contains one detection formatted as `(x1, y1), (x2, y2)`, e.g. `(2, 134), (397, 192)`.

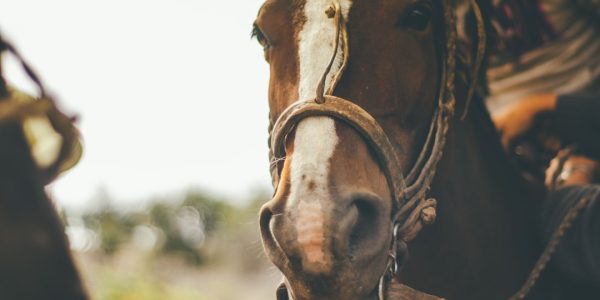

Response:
(269, 0), (457, 299)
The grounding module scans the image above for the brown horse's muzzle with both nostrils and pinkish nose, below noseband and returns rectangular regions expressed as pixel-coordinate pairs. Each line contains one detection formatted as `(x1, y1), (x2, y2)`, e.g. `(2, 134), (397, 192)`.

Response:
(260, 192), (391, 300)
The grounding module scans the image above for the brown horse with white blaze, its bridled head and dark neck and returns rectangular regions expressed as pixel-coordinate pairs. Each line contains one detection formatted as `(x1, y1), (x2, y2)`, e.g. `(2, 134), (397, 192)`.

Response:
(254, 0), (548, 299)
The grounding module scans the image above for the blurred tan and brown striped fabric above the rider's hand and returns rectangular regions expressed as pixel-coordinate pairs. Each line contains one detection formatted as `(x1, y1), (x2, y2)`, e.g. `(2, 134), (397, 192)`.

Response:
(488, 0), (600, 112)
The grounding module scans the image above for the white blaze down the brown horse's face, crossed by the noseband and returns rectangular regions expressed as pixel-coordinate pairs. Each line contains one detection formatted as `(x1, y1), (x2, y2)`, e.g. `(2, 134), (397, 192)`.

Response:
(287, 0), (351, 271)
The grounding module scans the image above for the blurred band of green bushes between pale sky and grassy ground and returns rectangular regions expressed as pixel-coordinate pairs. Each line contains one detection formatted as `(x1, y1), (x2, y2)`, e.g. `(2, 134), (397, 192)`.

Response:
(74, 189), (268, 265)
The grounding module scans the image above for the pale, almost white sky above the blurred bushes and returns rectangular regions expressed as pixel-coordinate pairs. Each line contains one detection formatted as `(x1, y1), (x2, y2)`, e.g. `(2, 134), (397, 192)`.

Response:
(0, 0), (270, 209)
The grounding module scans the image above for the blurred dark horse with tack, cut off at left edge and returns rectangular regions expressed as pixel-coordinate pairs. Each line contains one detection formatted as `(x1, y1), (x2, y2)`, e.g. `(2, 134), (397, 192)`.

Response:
(0, 35), (87, 300)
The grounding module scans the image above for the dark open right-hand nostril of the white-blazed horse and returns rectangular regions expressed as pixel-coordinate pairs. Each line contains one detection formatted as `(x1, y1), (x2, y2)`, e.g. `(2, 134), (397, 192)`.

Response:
(349, 195), (380, 256)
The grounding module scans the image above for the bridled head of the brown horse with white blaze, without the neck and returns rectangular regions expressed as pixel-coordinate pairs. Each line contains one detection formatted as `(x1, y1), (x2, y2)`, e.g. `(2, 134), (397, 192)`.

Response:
(253, 0), (455, 299)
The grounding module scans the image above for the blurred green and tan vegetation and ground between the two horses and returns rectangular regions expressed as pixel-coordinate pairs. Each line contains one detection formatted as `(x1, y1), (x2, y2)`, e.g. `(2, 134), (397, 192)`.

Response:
(63, 190), (280, 300)
